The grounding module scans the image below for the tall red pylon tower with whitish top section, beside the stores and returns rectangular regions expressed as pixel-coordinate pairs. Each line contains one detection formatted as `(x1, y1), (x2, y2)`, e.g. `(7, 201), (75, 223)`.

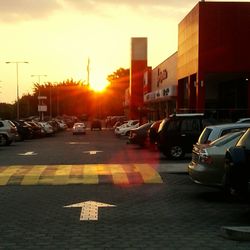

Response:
(129, 37), (147, 119)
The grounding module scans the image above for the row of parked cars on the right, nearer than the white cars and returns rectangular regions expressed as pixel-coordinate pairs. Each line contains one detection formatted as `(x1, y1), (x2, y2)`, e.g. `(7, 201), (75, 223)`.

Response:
(116, 114), (250, 197)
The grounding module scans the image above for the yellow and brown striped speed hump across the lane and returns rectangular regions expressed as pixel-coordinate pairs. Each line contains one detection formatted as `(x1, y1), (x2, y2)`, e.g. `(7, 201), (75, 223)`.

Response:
(0, 164), (163, 186)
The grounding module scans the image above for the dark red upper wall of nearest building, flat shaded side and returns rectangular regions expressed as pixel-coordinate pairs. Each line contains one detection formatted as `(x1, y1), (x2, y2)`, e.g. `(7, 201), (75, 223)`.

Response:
(199, 2), (250, 74)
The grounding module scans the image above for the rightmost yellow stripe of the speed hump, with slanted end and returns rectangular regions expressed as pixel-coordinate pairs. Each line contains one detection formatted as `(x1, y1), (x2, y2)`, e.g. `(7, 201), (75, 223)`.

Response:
(134, 164), (162, 183)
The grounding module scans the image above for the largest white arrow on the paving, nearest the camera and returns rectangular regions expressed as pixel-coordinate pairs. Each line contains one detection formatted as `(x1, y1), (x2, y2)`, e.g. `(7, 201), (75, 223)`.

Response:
(64, 201), (116, 220)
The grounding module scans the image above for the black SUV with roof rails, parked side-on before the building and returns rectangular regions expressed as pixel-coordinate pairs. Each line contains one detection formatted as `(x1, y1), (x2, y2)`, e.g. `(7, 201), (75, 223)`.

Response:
(157, 113), (213, 159)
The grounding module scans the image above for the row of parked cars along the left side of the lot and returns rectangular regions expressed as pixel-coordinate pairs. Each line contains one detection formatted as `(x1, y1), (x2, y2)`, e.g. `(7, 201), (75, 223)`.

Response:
(0, 119), (68, 146)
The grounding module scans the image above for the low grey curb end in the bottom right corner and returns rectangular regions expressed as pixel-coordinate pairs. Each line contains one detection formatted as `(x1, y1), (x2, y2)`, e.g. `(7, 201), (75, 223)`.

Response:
(221, 226), (250, 241)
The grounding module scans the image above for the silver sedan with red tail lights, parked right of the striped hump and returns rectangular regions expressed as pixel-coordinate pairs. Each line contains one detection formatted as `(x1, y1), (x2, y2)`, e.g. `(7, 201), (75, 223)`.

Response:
(188, 130), (245, 186)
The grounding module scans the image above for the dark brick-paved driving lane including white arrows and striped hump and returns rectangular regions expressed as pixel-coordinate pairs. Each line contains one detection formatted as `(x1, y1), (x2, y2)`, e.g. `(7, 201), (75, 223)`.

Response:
(0, 130), (250, 249)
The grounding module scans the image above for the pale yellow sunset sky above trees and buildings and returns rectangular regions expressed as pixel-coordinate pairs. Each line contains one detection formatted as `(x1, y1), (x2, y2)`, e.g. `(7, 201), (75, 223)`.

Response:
(0, 0), (247, 103)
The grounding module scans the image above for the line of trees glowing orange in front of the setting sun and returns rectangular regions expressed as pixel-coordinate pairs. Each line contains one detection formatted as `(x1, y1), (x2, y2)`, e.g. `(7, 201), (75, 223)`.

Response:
(0, 68), (129, 119)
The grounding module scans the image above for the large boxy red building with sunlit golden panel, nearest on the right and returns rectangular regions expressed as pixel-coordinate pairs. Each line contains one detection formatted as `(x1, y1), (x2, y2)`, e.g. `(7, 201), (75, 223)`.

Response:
(177, 2), (250, 119)
